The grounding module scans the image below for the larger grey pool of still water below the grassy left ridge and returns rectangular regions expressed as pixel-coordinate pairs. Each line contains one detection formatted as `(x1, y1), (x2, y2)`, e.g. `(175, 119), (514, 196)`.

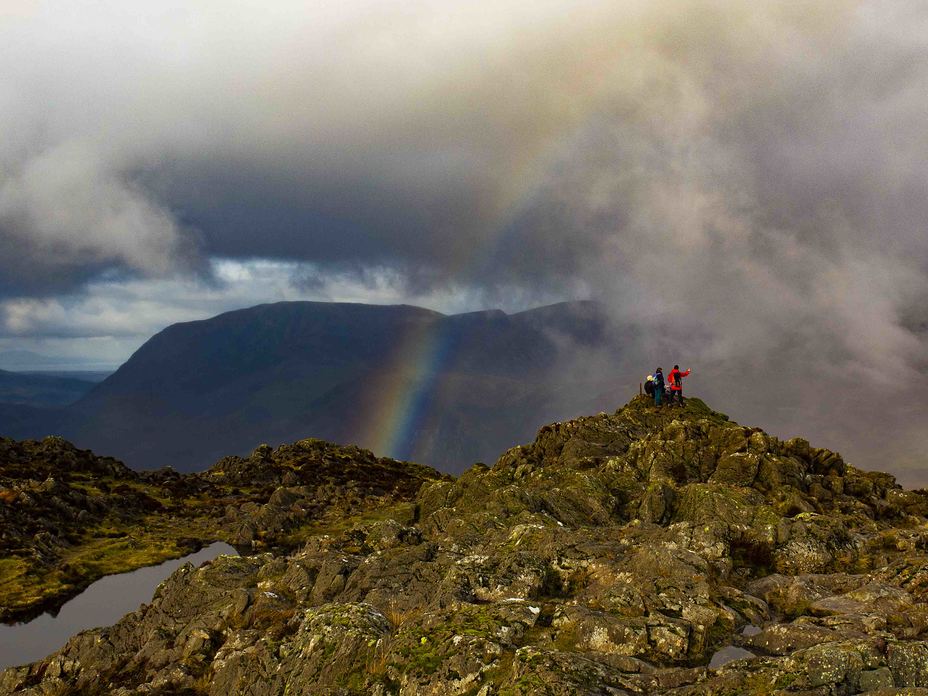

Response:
(0, 542), (238, 669)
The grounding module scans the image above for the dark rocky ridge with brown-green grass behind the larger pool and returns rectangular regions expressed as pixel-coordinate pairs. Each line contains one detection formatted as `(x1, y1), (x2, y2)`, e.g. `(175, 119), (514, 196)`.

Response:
(0, 437), (441, 621)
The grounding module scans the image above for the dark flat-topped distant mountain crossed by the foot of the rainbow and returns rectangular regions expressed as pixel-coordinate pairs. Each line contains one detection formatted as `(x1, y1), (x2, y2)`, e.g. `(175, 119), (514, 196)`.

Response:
(12, 302), (618, 472)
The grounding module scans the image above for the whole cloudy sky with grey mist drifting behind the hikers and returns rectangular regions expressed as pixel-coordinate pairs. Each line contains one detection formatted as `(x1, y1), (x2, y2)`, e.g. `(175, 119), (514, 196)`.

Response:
(0, 0), (928, 482)
